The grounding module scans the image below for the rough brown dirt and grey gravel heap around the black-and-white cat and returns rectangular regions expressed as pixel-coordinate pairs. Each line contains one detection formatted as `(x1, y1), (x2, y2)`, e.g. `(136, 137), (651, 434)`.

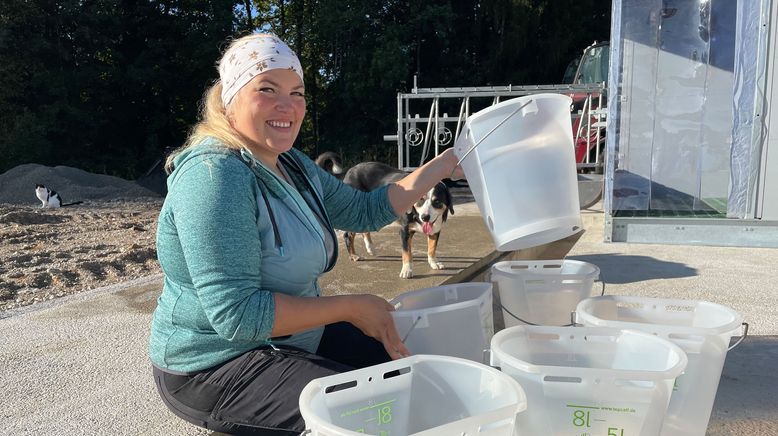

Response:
(0, 164), (164, 311)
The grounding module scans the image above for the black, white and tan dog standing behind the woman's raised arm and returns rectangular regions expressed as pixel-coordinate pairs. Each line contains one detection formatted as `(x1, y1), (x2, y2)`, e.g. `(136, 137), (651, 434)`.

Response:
(343, 162), (454, 279)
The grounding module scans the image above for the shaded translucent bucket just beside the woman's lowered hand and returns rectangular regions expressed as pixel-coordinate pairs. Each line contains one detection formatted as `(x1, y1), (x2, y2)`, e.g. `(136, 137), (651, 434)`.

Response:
(390, 282), (494, 363)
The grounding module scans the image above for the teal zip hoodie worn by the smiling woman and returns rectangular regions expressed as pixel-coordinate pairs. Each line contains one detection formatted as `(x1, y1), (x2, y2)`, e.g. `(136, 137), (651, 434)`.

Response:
(149, 139), (397, 374)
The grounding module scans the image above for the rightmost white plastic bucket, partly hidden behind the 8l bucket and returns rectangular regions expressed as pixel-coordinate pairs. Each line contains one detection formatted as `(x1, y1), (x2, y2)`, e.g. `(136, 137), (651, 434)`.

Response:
(576, 295), (743, 436)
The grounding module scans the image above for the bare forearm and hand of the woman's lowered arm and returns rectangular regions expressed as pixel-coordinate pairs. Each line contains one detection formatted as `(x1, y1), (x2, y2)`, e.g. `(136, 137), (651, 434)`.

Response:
(271, 293), (410, 359)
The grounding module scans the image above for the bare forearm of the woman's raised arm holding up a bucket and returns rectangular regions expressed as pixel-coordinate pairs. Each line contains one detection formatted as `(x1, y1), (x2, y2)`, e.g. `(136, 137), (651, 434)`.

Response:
(389, 148), (463, 215)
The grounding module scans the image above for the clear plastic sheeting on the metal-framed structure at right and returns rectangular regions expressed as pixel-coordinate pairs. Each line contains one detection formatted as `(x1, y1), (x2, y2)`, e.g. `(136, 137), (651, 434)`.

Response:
(605, 0), (769, 214)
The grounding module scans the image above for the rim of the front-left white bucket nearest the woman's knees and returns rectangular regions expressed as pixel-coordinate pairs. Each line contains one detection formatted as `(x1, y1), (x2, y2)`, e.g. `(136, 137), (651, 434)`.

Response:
(298, 354), (527, 436)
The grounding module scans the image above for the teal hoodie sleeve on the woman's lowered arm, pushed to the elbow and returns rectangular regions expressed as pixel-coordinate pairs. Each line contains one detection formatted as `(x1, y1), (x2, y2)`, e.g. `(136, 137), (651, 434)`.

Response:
(170, 155), (274, 342)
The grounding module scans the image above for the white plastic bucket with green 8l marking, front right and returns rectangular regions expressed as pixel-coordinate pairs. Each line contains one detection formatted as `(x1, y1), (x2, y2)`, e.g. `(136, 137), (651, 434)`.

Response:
(491, 326), (686, 436)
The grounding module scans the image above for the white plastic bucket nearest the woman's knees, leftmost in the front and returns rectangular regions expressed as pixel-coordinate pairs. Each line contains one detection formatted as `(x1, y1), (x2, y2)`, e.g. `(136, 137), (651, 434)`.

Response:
(300, 355), (527, 436)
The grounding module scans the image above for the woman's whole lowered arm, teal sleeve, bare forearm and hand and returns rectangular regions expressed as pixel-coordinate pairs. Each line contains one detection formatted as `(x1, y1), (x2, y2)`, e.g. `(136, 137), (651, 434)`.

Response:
(169, 153), (409, 359)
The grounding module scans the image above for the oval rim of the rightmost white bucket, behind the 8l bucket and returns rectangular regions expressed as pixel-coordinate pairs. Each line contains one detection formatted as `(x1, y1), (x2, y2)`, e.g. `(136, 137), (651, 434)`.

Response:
(575, 295), (743, 336)
